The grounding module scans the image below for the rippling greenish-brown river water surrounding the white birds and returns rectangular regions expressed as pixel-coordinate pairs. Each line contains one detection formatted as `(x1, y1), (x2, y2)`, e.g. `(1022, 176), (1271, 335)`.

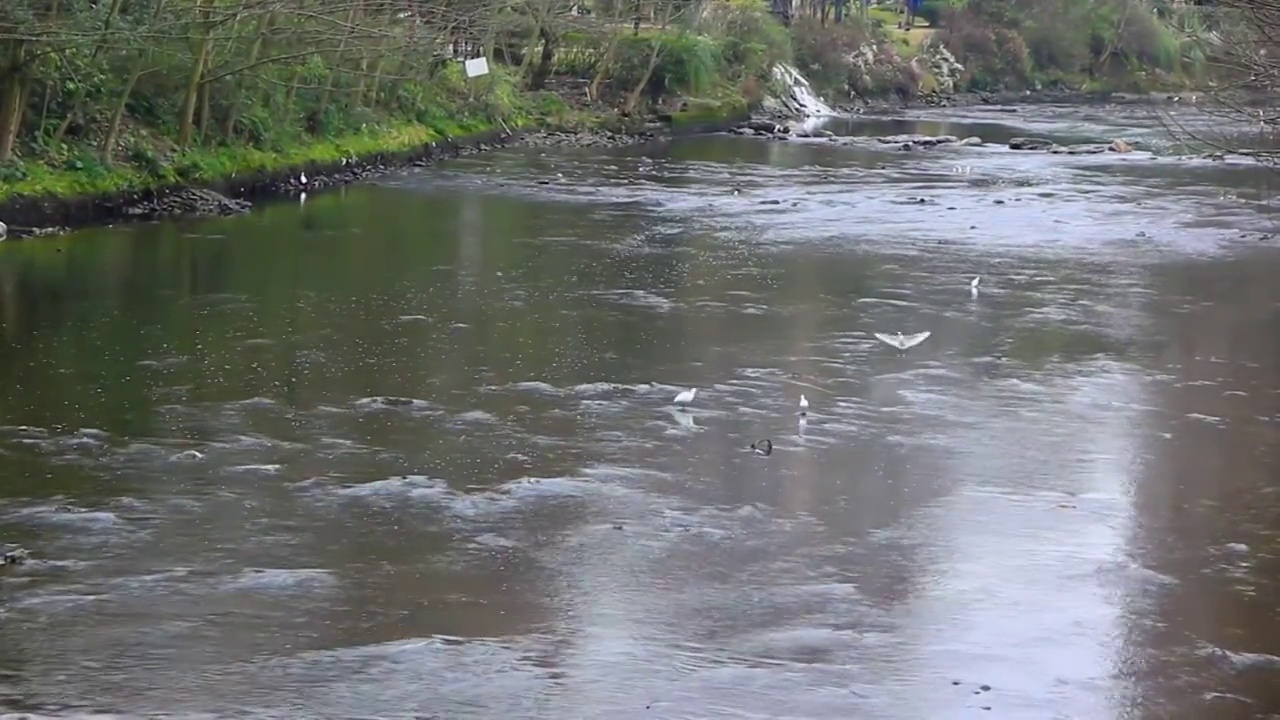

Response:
(0, 108), (1280, 720)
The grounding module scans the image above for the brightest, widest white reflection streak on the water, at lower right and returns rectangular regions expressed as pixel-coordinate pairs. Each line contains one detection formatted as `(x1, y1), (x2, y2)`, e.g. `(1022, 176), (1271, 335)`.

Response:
(902, 369), (1143, 719)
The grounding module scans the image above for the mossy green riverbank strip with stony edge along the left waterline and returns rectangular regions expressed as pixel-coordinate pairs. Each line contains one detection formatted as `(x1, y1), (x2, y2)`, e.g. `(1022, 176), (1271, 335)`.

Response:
(0, 104), (749, 238)
